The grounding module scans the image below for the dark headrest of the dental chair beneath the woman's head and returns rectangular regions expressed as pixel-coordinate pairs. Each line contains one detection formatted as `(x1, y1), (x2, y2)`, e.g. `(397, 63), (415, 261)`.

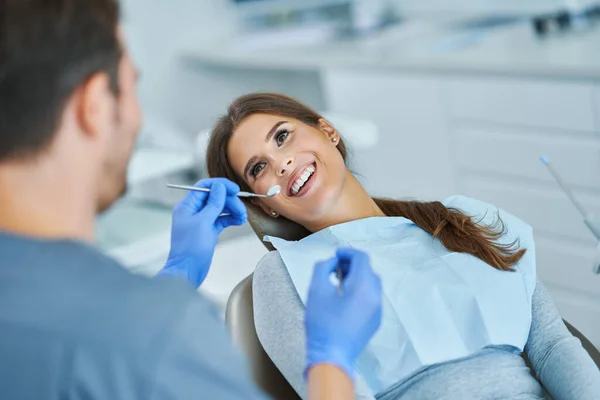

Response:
(246, 202), (310, 251)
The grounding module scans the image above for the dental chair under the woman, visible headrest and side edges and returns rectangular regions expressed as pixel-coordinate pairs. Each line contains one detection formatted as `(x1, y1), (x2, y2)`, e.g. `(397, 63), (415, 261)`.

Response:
(226, 205), (600, 400)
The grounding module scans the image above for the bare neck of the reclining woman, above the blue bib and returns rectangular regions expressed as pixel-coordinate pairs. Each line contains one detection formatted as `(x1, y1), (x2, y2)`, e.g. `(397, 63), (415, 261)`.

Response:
(304, 171), (385, 232)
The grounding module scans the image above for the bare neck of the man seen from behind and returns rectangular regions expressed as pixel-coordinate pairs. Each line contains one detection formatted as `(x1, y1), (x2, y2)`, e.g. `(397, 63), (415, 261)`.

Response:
(0, 160), (96, 242)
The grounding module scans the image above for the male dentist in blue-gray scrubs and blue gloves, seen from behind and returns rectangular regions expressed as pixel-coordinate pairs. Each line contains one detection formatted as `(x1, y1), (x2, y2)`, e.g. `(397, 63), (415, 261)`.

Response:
(0, 0), (381, 400)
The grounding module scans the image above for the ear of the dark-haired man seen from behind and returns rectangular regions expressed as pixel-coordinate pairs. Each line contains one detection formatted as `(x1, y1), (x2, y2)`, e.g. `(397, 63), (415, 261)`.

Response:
(77, 72), (116, 137)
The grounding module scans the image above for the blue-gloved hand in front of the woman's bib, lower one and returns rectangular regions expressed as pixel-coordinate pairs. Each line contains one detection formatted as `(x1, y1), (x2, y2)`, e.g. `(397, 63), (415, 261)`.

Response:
(304, 249), (382, 379)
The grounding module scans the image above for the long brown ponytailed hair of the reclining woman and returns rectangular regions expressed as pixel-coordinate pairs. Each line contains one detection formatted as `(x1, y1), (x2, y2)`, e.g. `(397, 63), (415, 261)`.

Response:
(207, 93), (526, 271)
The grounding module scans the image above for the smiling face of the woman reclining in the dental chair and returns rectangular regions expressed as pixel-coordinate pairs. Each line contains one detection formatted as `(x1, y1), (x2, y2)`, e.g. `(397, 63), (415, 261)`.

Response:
(227, 114), (347, 224)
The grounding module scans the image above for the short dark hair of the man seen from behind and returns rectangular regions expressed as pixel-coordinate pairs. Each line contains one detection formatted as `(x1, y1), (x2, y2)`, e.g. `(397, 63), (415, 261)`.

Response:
(0, 0), (122, 161)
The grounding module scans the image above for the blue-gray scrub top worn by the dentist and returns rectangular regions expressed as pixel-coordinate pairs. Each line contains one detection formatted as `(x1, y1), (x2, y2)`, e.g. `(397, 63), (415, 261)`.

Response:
(0, 233), (264, 400)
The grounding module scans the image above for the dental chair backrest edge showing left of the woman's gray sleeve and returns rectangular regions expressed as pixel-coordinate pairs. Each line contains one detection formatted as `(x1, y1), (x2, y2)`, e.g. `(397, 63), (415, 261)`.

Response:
(225, 275), (300, 400)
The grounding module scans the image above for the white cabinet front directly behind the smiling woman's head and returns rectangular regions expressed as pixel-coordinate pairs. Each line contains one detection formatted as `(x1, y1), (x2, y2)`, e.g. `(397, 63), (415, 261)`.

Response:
(322, 69), (456, 199)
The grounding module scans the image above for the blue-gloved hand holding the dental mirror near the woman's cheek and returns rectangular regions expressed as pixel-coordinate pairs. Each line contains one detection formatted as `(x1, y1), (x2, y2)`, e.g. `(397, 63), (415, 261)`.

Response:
(158, 178), (247, 288)
